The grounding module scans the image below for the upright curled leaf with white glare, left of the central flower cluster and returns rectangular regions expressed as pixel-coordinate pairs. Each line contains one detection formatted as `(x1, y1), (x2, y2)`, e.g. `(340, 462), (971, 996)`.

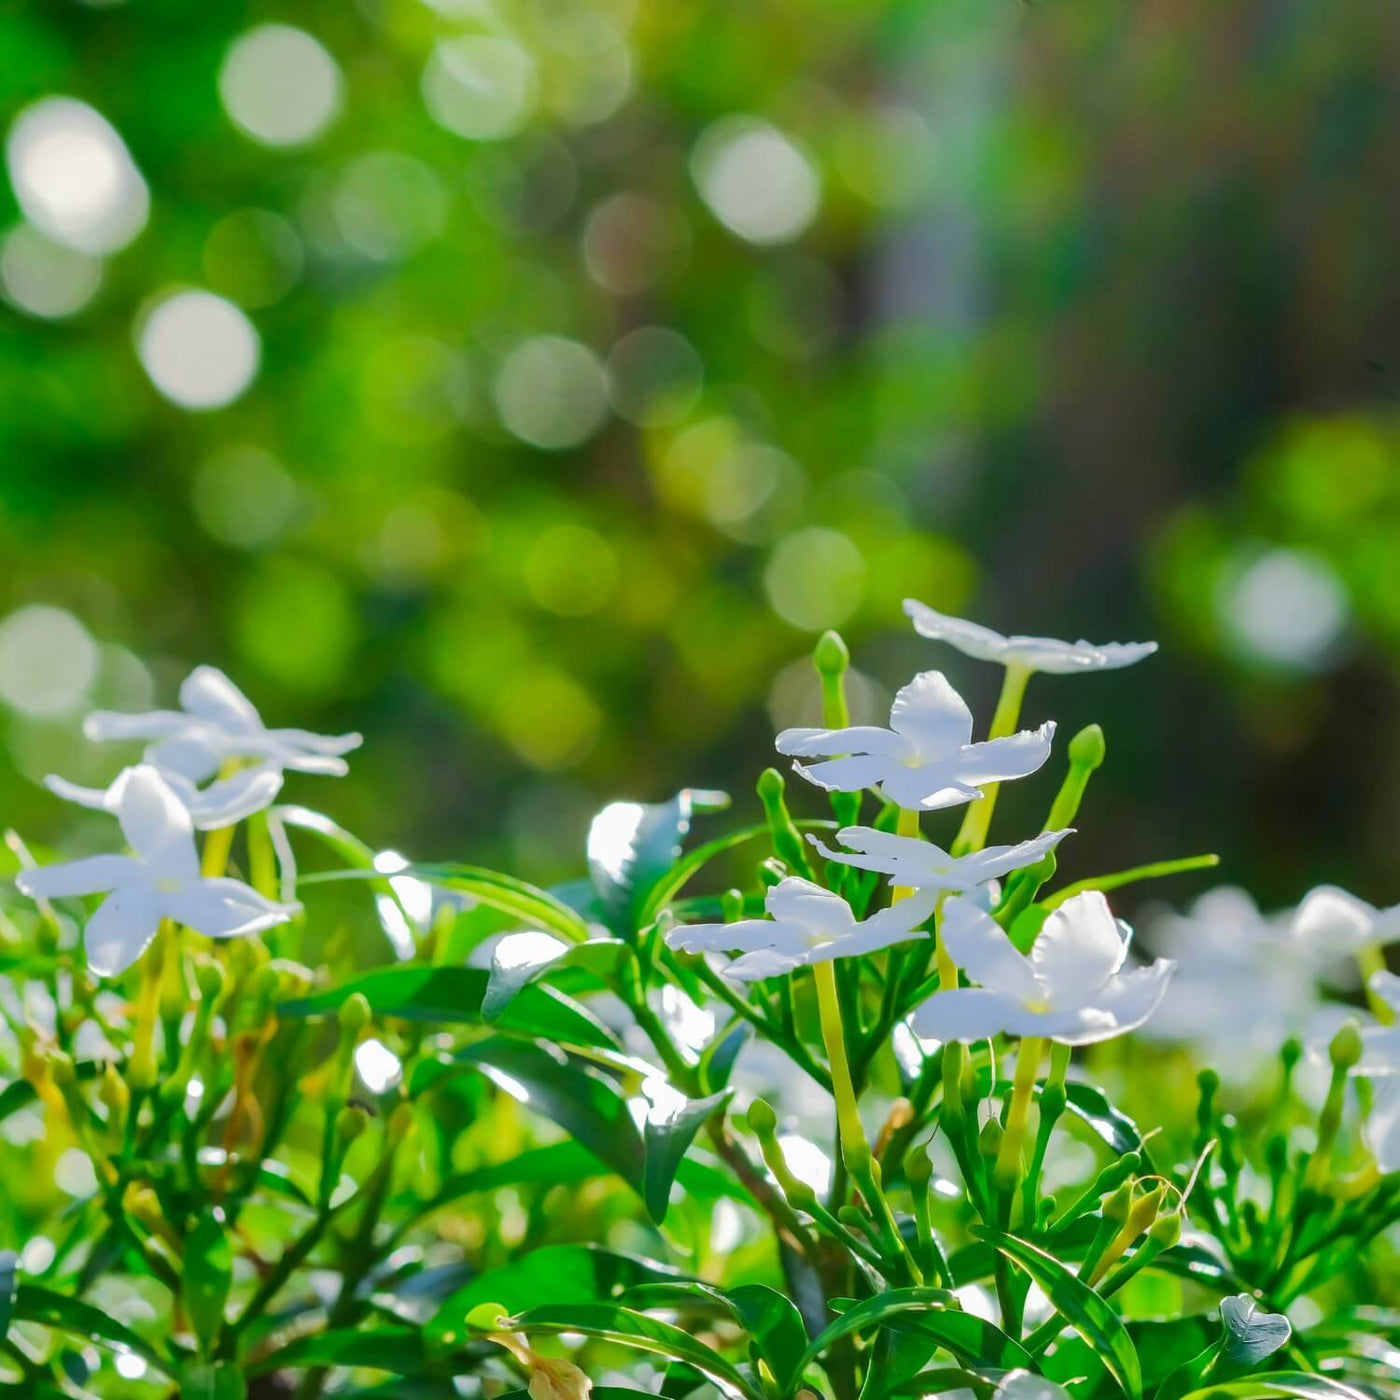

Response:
(588, 788), (729, 934)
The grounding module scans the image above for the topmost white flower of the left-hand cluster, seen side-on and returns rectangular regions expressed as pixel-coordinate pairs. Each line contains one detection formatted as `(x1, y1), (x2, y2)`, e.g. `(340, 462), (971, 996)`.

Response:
(83, 666), (360, 783)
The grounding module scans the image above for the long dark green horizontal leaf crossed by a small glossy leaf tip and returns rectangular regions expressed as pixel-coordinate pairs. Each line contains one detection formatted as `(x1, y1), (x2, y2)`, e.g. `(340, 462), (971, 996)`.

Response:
(277, 963), (617, 1050)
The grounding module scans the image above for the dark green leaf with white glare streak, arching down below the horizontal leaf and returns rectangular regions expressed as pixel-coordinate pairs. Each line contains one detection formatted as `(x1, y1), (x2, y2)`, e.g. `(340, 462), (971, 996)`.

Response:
(410, 1036), (645, 1198)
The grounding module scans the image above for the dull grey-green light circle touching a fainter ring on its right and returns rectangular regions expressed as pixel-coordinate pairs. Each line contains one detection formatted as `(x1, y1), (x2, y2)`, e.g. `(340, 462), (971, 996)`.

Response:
(496, 336), (608, 449)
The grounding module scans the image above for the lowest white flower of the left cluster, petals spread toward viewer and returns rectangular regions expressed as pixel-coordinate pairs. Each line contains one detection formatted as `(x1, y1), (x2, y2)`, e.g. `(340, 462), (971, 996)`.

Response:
(15, 763), (293, 977)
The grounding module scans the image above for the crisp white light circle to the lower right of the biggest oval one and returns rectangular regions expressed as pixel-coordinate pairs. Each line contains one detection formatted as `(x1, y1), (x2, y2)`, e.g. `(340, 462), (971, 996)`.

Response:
(136, 291), (262, 410)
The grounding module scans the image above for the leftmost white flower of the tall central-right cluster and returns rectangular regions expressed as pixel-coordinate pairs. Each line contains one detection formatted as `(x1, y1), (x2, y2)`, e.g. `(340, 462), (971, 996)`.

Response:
(666, 875), (937, 981)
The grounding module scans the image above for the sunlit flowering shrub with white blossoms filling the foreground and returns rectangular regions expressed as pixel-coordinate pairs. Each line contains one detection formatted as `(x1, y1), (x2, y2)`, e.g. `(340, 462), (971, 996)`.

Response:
(0, 603), (1400, 1400)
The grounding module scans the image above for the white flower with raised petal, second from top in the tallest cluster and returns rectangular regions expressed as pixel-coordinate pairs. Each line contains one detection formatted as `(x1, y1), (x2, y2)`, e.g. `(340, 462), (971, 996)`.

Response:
(777, 671), (1054, 811)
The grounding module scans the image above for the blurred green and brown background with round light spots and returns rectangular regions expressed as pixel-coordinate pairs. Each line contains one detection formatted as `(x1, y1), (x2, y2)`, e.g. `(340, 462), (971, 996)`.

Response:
(0, 0), (1400, 906)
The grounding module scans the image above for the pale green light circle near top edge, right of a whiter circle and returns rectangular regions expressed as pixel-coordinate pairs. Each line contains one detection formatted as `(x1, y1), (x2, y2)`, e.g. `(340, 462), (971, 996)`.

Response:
(423, 34), (536, 141)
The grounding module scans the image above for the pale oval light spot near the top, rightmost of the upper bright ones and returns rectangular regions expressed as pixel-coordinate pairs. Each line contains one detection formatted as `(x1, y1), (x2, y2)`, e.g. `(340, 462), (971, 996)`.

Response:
(690, 116), (822, 244)
